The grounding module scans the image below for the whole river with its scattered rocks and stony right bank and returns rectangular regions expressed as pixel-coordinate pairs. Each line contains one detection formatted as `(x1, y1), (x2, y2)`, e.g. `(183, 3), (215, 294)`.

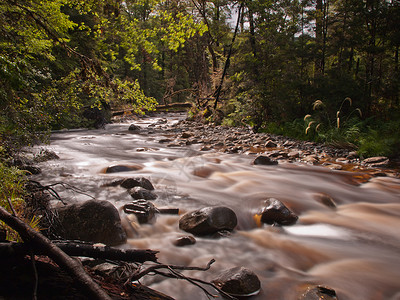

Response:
(10, 114), (400, 300)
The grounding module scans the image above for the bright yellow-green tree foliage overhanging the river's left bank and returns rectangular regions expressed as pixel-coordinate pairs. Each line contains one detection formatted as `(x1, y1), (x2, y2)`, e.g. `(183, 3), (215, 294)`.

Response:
(0, 0), (205, 150)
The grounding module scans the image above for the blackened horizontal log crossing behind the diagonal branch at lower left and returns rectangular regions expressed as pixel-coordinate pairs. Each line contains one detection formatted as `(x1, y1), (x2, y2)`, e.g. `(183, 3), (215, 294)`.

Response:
(0, 241), (158, 263)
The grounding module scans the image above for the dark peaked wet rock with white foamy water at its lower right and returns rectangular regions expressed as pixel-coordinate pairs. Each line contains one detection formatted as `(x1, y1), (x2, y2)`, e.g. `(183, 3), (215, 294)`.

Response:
(260, 198), (298, 225)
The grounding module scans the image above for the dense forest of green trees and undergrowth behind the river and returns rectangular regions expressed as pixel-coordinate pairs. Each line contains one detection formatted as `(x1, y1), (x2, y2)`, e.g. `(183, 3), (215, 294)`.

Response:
(0, 0), (400, 156)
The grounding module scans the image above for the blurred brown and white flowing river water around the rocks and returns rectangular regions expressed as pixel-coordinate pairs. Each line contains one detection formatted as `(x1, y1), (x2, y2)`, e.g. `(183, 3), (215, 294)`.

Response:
(36, 115), (400, 300)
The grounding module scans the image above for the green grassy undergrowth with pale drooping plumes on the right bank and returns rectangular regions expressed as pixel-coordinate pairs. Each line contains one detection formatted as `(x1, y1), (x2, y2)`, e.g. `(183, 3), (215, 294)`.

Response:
(223, 98), (400, 158)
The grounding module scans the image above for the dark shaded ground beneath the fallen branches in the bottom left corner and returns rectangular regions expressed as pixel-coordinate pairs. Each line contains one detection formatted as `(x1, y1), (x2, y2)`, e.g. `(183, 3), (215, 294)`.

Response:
(0, 256), (172, 300)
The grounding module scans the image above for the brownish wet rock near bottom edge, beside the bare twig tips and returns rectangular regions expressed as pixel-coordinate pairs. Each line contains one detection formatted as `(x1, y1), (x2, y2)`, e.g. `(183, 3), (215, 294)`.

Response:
(212, 267), (261, 297)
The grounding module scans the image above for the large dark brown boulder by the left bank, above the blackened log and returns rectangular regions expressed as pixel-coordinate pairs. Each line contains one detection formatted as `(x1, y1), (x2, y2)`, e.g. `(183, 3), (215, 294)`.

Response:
(54, 200), (126, 246)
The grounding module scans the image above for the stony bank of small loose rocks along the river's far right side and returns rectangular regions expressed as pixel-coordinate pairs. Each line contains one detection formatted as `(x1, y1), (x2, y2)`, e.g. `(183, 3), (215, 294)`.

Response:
(125, 114), (400, 177)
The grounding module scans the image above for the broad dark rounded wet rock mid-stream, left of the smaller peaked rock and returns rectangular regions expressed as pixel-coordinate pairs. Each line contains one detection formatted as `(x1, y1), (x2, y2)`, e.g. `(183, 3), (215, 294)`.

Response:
(179, 206), (237, 235)
